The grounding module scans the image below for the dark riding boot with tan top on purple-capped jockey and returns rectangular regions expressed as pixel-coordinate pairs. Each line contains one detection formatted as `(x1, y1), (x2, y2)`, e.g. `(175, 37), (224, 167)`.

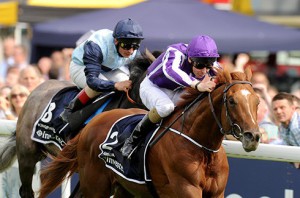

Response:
(120, 108), (162, 157)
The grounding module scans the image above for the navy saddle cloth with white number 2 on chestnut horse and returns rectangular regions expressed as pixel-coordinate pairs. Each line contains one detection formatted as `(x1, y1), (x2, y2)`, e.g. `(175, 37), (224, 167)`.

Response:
(98, 114), (158, 184)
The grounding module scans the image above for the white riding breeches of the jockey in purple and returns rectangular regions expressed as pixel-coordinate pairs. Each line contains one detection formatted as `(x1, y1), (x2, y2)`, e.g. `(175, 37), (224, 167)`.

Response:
(140, 76), (176, 118)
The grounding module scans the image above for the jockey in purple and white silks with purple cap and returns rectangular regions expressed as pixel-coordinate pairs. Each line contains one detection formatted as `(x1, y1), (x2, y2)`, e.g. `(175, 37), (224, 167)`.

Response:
(121, 35), (221, 157)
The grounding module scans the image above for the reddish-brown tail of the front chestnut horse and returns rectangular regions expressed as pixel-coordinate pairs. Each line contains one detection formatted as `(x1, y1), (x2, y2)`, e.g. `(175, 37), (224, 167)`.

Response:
(39, 134), (80, 198)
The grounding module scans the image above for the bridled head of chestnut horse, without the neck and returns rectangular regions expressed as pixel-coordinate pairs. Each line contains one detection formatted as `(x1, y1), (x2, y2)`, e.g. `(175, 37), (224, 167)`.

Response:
(218, 67), (261, 152)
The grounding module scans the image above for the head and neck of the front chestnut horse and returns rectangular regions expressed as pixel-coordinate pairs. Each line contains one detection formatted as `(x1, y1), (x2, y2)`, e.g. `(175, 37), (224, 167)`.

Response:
(176, 65), (261, 152)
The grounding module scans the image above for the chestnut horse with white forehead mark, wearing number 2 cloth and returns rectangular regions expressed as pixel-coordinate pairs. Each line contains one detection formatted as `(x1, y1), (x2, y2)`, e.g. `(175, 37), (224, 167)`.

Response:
(40, 68), (261, 198)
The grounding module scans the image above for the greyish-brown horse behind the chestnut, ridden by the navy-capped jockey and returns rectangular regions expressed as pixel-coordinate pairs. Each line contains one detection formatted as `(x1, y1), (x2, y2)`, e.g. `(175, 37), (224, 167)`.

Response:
(0, 54), (151, 198)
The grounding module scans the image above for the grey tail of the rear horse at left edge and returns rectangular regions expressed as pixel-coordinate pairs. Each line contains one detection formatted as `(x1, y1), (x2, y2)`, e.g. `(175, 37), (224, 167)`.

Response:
(0, 131), (17, 172)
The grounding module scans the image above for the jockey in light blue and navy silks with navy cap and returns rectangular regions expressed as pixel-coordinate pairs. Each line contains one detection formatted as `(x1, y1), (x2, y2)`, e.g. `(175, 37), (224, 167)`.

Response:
(60, 18), (144, 122)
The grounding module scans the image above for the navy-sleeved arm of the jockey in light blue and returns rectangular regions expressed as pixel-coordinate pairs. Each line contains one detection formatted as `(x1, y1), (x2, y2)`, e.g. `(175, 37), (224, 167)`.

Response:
(83, 41), (115, 92)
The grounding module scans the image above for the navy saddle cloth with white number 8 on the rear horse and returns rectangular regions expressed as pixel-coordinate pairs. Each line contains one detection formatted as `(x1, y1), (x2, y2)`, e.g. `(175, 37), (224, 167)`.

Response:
(31, 86), (115, 150)
